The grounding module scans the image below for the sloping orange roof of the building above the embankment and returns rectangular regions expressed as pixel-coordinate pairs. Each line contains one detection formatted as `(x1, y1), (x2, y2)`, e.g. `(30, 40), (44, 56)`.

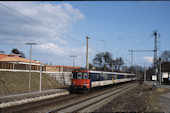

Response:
(0, 54), (42, 64)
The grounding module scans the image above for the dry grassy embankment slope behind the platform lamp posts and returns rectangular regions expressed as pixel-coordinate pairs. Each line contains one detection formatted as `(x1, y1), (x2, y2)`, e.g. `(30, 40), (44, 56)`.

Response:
(0, 72), (64, 95)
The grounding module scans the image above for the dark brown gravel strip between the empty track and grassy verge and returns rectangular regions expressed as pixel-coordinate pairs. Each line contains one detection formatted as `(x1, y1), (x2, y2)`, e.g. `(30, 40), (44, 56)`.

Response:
(94, 85), (148, 112)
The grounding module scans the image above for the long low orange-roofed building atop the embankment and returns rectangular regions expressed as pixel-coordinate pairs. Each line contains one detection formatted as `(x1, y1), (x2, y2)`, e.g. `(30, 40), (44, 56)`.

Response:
(0, 53), (80, 72)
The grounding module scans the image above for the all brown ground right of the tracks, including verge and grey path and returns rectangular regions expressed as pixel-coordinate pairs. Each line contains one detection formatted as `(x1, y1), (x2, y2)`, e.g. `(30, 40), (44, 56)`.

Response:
(94, 83), (170, 113)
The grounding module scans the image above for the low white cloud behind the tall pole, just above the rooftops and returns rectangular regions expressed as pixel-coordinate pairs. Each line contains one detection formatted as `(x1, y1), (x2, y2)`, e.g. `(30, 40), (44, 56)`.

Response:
(34, 43), (96, 67)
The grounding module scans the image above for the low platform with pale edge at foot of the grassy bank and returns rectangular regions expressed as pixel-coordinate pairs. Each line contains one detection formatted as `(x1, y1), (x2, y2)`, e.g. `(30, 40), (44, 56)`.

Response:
(0, 88), (70, 109)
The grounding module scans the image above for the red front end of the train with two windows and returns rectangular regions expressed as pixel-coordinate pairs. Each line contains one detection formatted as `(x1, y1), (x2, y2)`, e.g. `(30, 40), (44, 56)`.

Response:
(70, 70), (90, 93)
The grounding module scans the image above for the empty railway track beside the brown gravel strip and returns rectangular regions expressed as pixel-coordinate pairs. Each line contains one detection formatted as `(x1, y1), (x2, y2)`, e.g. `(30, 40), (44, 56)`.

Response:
(48, 84), (137, 113)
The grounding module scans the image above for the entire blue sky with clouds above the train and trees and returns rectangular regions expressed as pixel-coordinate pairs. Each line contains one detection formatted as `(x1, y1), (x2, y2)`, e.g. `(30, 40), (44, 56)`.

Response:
(0, 1), (170, 67)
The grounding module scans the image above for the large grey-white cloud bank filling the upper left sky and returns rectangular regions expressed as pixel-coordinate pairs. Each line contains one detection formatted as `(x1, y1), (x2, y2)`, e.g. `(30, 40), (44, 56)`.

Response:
(0, 2), (85, 43)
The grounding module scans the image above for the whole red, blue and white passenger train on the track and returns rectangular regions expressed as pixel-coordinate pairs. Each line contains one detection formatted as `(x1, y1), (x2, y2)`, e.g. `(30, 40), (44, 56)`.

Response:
(70, 69), (136, 93)
